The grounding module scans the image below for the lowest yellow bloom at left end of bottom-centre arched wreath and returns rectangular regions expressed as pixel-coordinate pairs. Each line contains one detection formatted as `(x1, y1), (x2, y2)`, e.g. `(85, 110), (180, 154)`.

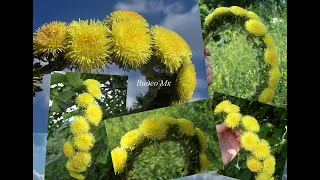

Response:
(111, 147), (128, 174)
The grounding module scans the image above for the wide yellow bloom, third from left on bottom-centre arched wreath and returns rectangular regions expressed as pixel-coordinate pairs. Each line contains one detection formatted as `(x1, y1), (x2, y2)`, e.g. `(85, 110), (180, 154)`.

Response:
(139, 119), (168, 140)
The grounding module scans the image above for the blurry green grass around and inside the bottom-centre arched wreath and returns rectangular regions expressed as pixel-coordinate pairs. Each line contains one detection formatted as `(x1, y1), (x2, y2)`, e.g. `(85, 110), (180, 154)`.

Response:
(105, 99), (223, 180)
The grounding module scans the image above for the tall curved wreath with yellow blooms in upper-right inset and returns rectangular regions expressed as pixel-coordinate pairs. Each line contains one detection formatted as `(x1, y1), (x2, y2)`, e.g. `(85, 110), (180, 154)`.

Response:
(202, 6), (280, 103)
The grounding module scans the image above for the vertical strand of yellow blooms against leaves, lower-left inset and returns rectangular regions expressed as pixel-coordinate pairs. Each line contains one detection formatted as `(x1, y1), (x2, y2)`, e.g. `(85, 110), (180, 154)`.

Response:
(63, 79), (102, 180)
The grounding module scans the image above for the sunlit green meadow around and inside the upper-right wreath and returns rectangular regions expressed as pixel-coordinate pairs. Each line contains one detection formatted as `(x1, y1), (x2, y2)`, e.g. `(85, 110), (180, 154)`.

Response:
(199, 0), (287, 107)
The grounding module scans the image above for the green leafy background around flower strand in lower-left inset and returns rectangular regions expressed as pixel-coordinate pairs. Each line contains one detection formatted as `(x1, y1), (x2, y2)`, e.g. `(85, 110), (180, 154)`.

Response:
(45, 72), (128, 180)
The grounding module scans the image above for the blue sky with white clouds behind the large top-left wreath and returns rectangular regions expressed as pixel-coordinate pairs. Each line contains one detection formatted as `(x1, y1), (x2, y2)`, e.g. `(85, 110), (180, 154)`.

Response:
(33, 0), (208, 174)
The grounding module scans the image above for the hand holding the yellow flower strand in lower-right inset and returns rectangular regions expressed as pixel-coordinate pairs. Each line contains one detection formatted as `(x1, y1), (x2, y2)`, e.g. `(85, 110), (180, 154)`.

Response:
(216, 124), (241, 165)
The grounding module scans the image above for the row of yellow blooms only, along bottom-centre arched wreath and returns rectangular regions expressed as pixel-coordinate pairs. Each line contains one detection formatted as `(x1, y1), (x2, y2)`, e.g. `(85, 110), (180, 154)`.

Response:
(111, 116), (208, 174)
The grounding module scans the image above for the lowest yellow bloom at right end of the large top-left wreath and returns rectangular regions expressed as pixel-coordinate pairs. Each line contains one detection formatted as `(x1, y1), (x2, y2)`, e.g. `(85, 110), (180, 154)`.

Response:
(176, 64), (197, 102)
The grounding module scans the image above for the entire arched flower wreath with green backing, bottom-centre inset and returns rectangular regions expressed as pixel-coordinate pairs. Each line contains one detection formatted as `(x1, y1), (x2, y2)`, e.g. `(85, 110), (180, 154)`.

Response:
(111, 116), (208, 179)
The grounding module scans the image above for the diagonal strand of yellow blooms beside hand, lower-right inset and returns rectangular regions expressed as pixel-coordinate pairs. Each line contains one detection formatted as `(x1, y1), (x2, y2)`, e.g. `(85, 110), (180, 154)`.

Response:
(214, 100), (276, 180)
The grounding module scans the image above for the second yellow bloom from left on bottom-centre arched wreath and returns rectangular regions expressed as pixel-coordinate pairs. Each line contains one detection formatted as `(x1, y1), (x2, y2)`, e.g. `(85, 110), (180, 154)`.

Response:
(120, 129), (143, 148)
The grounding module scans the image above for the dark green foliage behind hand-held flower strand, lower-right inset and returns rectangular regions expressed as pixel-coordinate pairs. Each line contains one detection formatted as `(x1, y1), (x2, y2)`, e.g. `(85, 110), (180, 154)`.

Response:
(212, 92), (287, 180)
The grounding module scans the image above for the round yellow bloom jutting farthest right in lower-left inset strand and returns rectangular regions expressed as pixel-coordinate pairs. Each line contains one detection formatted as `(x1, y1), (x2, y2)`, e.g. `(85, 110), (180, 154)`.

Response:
(84, 103), (103, 126)
